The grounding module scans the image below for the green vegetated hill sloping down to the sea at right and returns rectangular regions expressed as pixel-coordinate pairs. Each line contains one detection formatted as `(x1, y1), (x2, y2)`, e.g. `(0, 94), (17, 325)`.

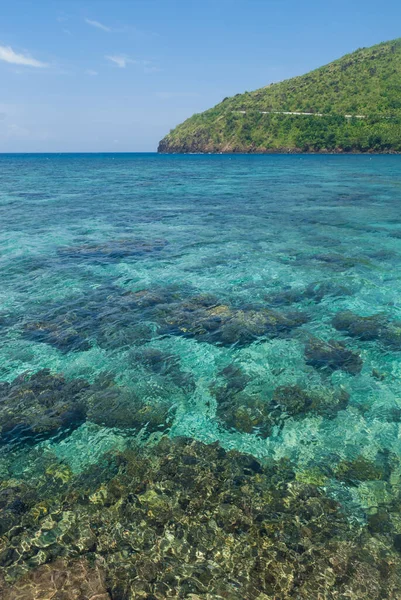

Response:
(158, 38), (401, 153)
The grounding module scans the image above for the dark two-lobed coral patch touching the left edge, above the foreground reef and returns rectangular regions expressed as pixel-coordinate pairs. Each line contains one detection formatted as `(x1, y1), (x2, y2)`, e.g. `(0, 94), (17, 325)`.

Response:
(0, 369), (174, 443)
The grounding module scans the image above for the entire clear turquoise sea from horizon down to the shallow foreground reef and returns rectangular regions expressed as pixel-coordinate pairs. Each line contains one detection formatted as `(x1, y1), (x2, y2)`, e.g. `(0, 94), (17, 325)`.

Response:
(0, 153), (401, 600)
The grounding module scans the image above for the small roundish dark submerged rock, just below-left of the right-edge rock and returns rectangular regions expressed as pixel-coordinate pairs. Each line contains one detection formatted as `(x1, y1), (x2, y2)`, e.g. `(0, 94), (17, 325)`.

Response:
(305, 337), (363, 375)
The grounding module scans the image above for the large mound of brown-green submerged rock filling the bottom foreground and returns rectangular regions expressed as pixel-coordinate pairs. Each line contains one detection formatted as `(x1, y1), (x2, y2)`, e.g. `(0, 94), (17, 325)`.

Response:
(0, 438), (401, 600)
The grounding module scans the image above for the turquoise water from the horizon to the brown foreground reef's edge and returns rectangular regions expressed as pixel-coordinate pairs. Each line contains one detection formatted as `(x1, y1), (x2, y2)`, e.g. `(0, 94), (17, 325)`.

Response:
(0, 154), (401, 598)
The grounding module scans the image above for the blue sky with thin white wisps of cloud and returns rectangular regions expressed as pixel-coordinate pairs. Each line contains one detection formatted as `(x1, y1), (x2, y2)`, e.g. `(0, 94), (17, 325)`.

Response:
(0, 0), (401, 152)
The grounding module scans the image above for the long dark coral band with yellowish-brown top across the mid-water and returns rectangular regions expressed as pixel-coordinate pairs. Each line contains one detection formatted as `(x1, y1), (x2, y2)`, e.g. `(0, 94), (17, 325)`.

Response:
(23, 285), (308, 352)
